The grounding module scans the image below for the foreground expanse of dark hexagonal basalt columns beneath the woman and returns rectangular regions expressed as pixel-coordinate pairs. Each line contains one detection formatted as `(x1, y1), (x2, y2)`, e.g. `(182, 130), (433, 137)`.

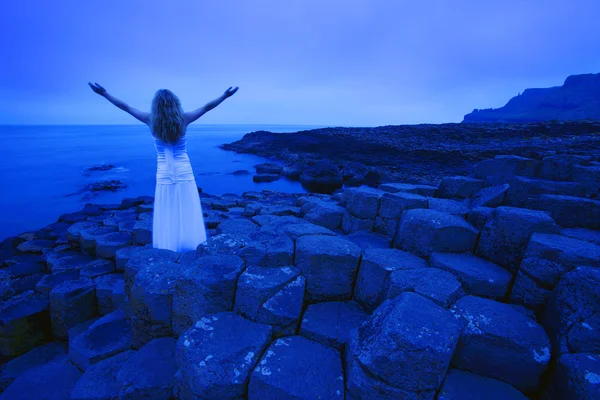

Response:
(0, 151), (600, 400)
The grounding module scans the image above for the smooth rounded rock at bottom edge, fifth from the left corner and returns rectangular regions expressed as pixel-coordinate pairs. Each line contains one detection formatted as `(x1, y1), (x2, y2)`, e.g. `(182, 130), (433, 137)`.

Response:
(248, 336), (344, 399)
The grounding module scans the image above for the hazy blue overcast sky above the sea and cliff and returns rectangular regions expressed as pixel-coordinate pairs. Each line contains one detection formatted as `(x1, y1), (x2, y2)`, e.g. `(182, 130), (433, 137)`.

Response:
(0, 0), (600, 126)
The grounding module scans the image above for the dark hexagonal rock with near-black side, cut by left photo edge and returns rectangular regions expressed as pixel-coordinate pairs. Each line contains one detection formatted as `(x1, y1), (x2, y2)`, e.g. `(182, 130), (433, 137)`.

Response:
(0, 290), (50, 357)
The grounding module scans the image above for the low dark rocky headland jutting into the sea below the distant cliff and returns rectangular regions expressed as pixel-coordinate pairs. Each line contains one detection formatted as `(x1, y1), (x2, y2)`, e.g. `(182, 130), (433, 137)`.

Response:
(221, 121), (600, 193)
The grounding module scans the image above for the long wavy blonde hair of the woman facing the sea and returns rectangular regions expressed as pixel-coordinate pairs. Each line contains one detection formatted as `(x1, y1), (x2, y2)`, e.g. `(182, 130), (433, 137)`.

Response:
(150, 89), (184, 143)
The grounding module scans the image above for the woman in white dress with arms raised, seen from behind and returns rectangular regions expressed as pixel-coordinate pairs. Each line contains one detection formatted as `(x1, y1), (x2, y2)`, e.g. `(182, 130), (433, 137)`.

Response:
(88, 82), (238, 252)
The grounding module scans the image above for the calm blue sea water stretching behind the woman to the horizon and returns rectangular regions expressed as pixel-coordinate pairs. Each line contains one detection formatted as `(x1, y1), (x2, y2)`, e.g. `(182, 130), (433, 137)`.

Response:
(0, 124), (318, 240)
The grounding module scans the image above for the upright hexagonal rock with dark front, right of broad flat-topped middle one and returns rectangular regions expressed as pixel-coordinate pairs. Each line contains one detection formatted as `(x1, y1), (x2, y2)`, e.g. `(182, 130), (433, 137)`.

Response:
(476, 207), (558, 272)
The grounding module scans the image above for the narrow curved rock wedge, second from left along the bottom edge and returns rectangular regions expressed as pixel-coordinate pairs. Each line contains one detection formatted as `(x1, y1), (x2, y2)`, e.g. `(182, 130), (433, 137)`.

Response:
(69, 350), (135, 400)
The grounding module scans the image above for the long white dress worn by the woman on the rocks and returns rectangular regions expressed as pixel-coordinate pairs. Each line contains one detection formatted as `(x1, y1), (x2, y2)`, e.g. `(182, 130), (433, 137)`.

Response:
(152, 130), (207, 252)
